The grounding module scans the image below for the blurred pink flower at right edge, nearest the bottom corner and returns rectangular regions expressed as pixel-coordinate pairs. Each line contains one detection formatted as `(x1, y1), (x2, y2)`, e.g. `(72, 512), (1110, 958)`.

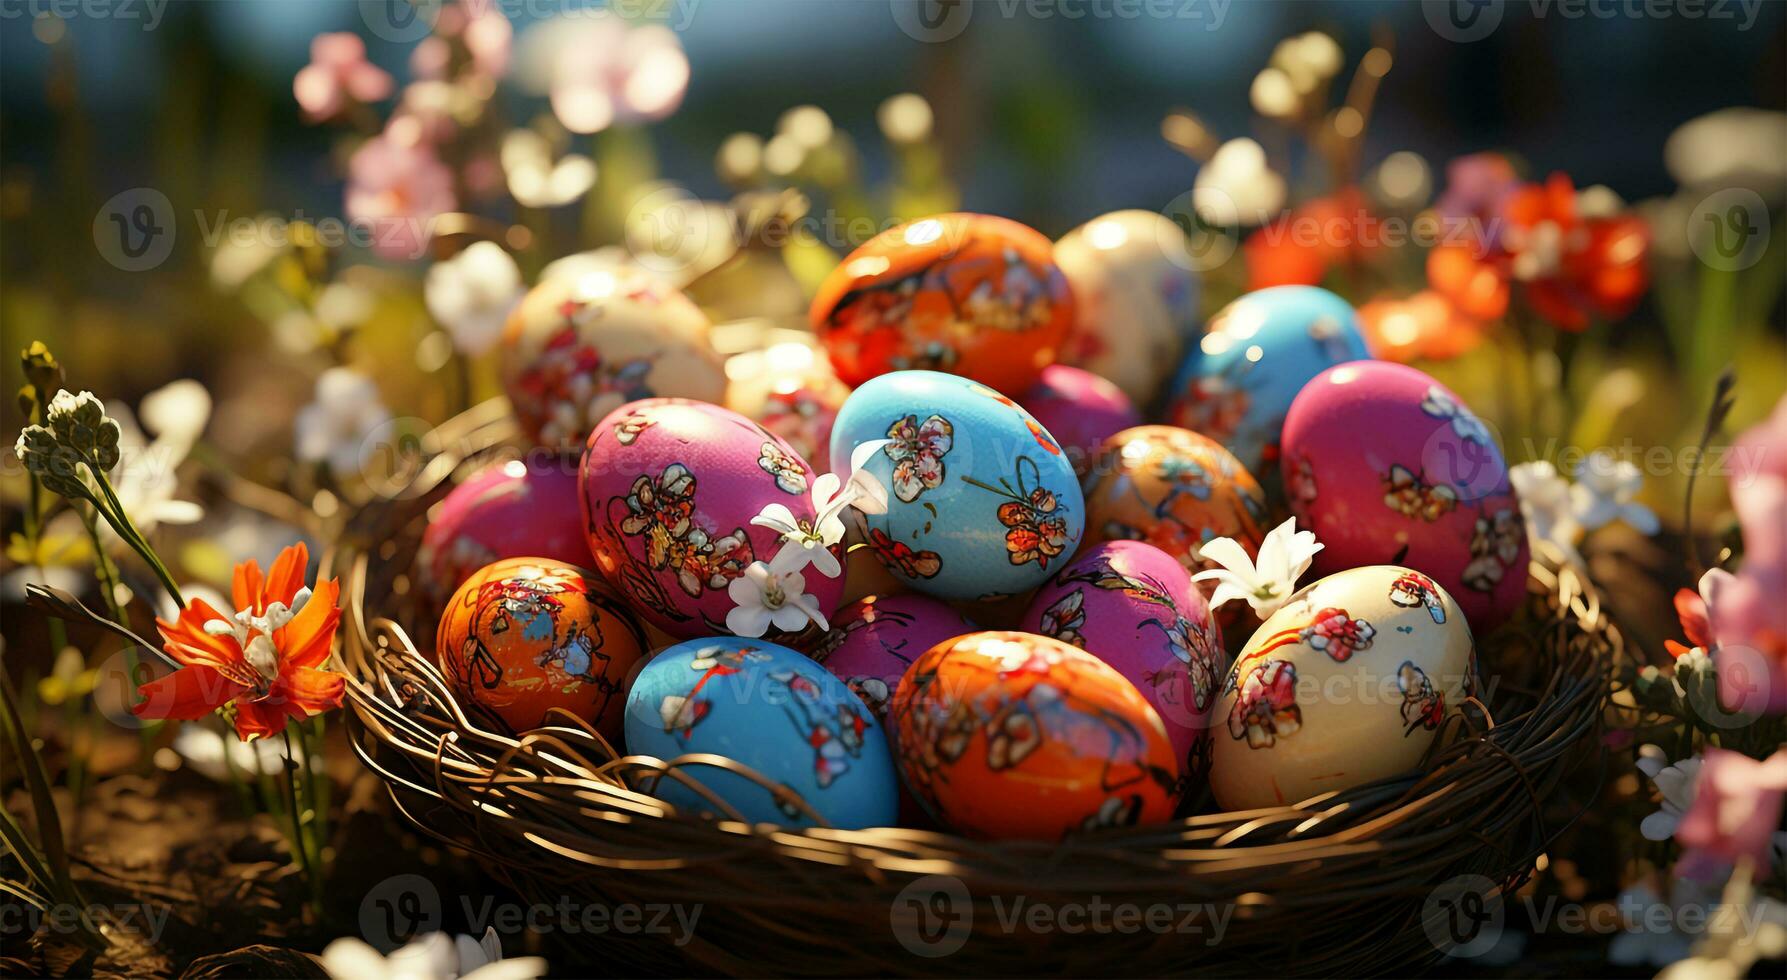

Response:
(1676, 749), (1787, 880)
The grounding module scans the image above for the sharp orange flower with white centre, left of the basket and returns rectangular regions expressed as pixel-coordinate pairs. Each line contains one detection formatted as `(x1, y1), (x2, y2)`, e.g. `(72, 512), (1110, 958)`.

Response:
(130, 542), (347, 742)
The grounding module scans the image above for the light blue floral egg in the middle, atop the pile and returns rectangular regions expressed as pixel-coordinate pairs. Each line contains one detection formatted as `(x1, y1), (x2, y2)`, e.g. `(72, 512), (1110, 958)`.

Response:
(831, 370), (1085, 599)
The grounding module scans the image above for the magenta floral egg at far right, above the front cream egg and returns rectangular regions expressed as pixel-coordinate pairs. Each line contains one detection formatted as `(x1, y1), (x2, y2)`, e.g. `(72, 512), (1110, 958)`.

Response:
(1281, 361), (1526, 629)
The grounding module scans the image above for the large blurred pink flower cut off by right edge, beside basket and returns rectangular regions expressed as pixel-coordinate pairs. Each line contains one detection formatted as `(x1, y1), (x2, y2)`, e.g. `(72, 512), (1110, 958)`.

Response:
(1699, 397), (1787, 714)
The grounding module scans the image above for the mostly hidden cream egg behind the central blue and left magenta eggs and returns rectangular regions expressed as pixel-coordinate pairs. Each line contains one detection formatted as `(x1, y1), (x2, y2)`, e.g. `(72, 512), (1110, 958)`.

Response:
(726, 343), (851, 472)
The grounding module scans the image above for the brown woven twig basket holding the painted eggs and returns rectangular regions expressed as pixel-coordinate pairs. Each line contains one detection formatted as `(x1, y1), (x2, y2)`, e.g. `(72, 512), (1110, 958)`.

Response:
(325, 401), (1624, 976)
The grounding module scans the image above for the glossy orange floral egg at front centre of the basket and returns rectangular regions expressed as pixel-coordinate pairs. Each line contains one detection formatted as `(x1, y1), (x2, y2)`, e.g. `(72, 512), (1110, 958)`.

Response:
(888, 631), (1181, 841)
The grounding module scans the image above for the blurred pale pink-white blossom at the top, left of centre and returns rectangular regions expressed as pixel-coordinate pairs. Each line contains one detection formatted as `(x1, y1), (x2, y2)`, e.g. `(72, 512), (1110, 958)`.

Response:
(541, 16), (688, 132)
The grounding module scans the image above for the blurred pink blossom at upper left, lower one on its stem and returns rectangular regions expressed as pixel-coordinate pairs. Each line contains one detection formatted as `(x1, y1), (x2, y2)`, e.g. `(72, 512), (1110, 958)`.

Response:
(347, 132), (457, 259)
